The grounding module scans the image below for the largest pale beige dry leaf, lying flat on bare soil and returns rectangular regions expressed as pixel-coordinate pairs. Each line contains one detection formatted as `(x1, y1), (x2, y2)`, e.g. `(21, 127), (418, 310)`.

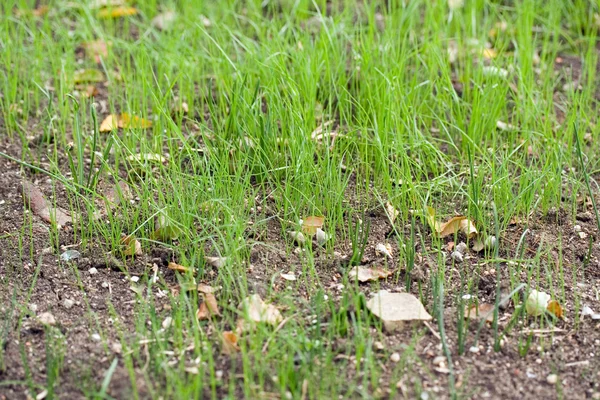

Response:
(367, 290), (431, 332)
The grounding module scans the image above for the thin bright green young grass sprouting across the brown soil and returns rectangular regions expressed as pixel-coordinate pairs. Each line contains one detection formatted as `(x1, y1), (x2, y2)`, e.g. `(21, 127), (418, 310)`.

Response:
(0, 0), (600, 398)
